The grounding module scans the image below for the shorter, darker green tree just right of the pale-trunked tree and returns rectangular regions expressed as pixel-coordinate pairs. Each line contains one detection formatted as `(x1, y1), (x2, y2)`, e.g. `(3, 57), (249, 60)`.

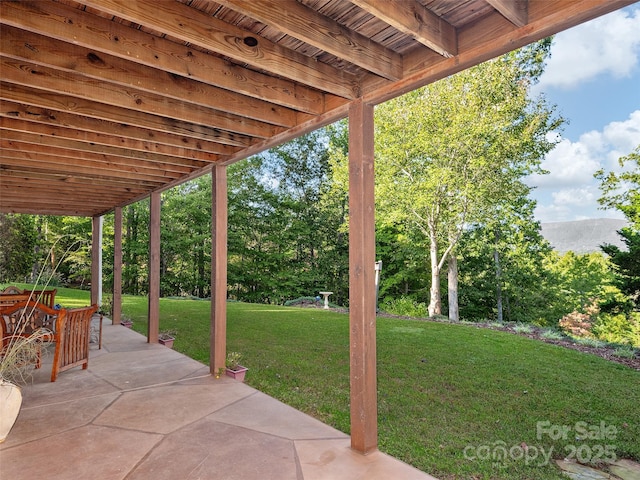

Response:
(460, 198), (557, 323)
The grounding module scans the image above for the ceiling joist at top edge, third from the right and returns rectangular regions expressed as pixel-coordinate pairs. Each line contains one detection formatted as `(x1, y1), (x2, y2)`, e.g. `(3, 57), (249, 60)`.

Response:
(216, 0), (402, 80)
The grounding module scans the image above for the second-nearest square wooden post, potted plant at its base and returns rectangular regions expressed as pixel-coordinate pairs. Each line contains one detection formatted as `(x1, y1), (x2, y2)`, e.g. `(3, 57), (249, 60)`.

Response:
(209, 165), (227, 375)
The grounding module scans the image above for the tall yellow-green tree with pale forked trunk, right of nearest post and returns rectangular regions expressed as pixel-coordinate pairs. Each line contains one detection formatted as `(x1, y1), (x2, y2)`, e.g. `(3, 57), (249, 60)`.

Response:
(376, 40), (562, 315)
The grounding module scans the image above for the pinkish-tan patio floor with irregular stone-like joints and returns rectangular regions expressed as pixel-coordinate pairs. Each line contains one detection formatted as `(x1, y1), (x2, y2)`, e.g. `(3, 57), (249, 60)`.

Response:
(0, 321), (433, 480)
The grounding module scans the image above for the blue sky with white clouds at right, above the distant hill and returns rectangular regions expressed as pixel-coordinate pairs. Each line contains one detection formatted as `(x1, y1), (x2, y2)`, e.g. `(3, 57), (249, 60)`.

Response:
(528, 5), (640, 222)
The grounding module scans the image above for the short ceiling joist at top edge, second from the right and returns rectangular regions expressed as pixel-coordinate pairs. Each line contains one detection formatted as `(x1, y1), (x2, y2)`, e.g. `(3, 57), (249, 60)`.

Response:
(351, 0), (456, 58)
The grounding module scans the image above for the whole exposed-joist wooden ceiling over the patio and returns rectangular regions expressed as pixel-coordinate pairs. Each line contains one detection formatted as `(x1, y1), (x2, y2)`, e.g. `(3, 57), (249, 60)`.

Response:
(0, 0), (634, 216)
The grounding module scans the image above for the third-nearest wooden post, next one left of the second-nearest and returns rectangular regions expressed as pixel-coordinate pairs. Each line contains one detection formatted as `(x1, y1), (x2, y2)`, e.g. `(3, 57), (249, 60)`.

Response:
(147, 192), (161, 343)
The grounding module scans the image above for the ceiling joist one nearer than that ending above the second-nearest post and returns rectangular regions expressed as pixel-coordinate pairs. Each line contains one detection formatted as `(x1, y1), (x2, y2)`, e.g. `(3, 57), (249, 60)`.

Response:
(0, 99), (238, 156)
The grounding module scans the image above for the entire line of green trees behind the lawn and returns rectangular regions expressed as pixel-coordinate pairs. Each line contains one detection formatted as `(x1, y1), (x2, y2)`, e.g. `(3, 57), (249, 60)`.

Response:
(0, 39), (640, 344)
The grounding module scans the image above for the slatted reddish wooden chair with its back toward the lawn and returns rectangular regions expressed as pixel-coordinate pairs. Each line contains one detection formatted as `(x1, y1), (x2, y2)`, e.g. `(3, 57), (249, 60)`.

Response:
(51, 305), (98, 382)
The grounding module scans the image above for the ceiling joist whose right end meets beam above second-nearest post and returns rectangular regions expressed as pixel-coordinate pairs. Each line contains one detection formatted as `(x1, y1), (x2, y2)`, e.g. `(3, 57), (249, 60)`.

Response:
(0, 125), (217, 169)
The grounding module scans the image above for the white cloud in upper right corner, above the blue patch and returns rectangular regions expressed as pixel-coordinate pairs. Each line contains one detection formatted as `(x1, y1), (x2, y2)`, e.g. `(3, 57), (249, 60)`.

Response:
(537, 7), (640, 89)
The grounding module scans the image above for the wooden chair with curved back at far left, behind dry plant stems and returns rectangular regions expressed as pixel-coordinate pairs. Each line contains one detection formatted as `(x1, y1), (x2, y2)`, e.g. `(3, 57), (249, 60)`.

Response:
(0, 300), (61, 368)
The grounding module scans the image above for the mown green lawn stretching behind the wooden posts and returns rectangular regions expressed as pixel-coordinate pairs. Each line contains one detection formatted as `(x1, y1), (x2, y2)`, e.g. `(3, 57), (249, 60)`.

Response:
(11, 289), (640, 480)
